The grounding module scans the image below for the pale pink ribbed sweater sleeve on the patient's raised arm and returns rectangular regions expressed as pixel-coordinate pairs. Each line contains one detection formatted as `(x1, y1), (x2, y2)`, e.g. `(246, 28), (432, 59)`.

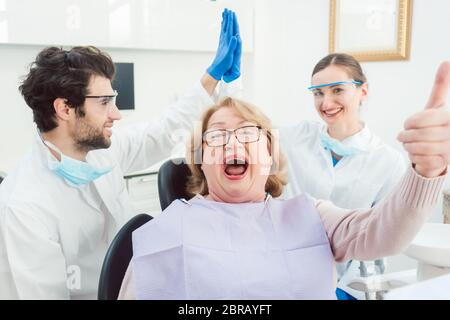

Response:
(316, 167), (445, 262)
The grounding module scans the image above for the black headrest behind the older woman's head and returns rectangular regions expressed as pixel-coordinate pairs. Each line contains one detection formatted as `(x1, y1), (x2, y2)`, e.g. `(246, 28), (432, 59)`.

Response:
(158, 158), (192, 210)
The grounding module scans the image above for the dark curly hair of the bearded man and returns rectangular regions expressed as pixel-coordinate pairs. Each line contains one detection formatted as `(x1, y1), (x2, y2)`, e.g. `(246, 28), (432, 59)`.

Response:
(19, 46), (115, 132)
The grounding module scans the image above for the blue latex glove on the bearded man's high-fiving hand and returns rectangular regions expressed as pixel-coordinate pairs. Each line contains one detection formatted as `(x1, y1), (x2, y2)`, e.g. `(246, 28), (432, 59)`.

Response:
(207, 9), (238, 81)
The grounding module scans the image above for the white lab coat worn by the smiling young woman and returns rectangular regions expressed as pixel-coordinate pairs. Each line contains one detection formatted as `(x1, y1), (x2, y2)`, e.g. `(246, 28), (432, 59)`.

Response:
(280, 121), (406, 299)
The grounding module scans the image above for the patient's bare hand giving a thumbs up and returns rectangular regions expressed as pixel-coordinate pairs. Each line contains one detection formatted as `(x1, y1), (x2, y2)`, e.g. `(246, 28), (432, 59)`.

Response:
(398, 61), (450, 178)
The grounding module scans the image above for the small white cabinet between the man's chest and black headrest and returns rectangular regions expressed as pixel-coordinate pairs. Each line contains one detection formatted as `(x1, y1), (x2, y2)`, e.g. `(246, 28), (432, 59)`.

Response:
(125, 172), (161, 216)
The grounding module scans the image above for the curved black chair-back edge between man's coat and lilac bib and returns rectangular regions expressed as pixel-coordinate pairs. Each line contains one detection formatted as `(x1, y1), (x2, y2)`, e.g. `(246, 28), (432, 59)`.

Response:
(97, 213), (153, 300)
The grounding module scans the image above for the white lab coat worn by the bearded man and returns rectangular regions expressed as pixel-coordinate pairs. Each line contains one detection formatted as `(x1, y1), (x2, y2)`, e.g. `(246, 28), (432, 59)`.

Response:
(0, 83), (237, 299)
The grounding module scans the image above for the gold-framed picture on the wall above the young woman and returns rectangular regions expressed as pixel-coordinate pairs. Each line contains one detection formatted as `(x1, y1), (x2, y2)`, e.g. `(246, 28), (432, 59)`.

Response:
(329, 0), (413, 61)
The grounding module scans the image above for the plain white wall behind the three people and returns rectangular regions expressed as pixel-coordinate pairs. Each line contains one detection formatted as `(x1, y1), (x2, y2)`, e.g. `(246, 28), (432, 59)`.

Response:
(0, 0), (450, 272)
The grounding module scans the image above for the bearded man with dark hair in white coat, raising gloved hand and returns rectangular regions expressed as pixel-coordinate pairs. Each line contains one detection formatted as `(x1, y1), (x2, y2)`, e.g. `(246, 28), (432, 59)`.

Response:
(0, 10), (241, 299)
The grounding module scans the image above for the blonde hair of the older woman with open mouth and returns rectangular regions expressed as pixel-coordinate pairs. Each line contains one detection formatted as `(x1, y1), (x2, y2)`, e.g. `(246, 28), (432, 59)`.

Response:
(186, 98), (287, 198)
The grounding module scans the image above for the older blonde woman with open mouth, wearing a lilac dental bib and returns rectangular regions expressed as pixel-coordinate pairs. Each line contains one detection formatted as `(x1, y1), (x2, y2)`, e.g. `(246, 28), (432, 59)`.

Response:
(119, 64), (450, 299)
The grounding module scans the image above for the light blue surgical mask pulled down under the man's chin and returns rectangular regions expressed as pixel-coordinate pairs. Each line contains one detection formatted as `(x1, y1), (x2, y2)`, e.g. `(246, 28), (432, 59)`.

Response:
(43, 140), (112, 185)
